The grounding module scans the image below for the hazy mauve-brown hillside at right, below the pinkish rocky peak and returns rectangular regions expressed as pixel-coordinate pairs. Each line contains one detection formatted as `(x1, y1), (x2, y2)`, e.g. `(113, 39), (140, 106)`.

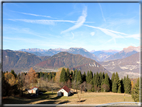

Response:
(100, 52), (140, 77)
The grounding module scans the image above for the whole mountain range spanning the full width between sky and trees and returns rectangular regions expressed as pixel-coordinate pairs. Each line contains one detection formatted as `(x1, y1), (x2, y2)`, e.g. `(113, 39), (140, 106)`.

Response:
(3, 46), (140, 77)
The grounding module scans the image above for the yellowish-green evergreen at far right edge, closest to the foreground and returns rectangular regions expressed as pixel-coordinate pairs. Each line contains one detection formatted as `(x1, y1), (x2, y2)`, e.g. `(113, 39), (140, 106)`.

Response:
(132, 78), (140, 102)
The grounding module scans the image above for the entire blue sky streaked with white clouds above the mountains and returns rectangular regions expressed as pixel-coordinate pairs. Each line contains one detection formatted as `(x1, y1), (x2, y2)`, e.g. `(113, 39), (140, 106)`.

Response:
(3, 3), (140, 51)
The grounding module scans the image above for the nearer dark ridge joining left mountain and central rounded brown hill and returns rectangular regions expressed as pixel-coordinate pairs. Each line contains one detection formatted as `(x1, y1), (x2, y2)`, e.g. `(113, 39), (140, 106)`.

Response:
(3, 50), (111, 76)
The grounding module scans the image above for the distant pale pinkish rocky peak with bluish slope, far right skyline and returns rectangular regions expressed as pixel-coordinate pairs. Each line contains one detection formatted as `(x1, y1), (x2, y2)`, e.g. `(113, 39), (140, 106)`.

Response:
(105, 46), (140, 61)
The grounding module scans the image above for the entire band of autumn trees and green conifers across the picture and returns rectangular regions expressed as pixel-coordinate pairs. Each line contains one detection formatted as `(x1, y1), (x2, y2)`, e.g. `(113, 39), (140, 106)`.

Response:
(2, 68), (140, 101)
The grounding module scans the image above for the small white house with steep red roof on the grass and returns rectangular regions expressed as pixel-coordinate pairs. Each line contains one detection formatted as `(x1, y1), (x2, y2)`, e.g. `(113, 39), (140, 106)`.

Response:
(57, 86), (71, 96)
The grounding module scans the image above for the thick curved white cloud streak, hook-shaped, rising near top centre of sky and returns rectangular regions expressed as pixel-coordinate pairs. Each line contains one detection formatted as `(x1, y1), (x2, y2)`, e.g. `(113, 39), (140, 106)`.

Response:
(61, 7), (87, 34)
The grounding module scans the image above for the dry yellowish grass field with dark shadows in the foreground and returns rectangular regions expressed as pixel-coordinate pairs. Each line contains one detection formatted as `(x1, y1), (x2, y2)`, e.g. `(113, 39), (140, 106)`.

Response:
(2, 91), (134, 104)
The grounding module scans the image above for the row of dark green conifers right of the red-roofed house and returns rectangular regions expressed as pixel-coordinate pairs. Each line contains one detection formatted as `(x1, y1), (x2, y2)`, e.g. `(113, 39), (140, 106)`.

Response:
(60, 68), (131, 94)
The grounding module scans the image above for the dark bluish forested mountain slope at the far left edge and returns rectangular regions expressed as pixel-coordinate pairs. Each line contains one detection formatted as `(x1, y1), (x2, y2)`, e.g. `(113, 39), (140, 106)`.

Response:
(3, 50), (42, 72)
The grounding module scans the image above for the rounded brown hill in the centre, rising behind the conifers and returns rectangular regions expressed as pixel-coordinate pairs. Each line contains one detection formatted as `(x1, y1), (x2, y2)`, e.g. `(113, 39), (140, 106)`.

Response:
(34, 52), (111, 76)
